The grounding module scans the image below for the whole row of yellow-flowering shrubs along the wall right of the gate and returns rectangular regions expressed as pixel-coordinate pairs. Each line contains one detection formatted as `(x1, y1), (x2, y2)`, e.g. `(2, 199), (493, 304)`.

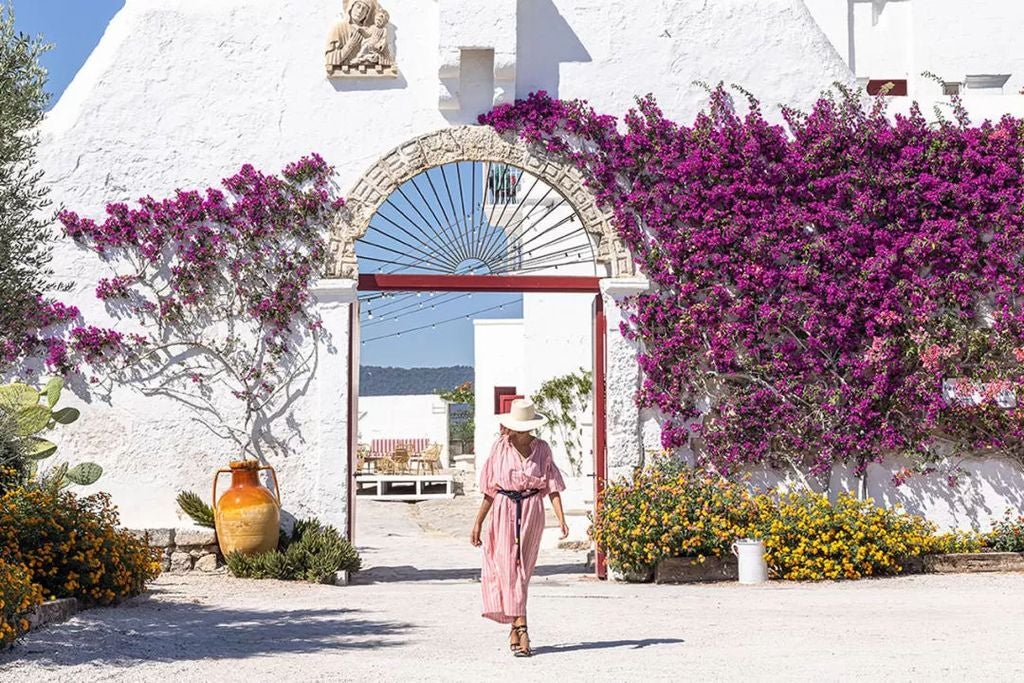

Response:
(591, 459), (958, 581)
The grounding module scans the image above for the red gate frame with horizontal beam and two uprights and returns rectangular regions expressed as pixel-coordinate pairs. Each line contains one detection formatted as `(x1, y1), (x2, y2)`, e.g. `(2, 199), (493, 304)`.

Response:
(348, 274), (608, 579)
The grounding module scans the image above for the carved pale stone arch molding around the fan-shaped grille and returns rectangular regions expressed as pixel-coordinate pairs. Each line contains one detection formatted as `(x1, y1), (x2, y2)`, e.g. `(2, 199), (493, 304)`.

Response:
(326, 126), (636, 279)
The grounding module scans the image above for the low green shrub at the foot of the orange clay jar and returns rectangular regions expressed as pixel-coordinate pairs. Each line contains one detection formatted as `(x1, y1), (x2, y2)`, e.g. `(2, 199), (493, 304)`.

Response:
(224, 519), (361, 584)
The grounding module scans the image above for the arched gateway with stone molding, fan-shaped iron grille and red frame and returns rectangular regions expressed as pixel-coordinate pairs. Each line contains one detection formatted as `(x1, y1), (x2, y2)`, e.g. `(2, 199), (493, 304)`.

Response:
(342, 126), (638, 572)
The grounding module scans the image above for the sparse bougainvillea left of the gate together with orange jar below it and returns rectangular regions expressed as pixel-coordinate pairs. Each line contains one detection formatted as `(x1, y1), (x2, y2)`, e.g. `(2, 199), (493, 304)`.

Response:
(59, 155), (343, 555)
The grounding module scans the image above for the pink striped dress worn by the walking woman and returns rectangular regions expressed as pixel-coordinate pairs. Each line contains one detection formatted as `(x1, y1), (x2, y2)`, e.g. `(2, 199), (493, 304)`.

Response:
(480, 437), (565, 624)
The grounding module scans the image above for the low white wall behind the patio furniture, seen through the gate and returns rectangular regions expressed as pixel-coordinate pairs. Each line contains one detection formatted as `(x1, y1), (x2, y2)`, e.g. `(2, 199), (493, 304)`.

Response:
(358, 394), (449, 467)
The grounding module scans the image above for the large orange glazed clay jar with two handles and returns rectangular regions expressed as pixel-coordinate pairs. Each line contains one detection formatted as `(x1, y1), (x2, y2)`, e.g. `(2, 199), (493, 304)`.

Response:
(213, 460), (281, 555)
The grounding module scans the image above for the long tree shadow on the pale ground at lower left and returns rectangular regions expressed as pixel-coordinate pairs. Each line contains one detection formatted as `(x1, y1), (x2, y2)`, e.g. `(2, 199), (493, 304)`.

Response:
(0, 596), (413, 663)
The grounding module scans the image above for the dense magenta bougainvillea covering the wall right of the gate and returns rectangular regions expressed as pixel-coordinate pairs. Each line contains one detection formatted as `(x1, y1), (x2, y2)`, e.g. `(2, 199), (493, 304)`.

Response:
(481, 87), (1024, 481)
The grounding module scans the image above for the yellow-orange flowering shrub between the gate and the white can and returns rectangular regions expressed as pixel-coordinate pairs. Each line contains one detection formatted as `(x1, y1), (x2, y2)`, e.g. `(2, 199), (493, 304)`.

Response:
(591, 460), (754, 571)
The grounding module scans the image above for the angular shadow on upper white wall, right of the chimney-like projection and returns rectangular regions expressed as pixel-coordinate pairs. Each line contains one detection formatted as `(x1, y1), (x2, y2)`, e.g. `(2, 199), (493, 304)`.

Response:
(516, 0), (592, 97)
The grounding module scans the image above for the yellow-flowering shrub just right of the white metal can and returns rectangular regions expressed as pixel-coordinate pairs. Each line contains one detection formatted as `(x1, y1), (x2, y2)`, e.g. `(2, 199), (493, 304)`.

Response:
(755, 492), (934, 581)
